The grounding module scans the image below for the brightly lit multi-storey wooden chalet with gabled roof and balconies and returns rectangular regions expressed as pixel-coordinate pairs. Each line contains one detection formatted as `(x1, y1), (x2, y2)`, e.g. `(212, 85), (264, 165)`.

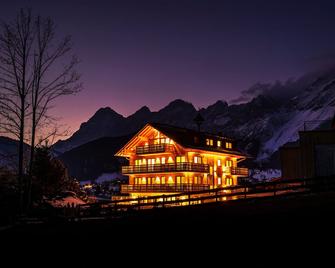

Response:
(116, 123), (248, 197)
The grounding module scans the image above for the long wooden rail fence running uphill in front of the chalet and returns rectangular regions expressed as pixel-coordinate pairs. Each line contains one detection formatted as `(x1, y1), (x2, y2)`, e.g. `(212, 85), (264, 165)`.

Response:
(76, 177), (335, 218)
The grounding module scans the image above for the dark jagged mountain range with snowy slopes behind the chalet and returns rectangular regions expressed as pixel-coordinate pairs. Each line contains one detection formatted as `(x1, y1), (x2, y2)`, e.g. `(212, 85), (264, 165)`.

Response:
(1, 68), (335, 178)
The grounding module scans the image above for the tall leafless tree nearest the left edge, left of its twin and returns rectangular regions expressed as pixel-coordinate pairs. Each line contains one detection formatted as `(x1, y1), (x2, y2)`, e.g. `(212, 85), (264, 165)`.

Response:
(0, 10), (34, 208)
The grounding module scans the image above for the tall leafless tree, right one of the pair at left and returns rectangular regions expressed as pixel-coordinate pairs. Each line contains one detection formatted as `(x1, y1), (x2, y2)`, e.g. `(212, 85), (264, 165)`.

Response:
(29, 16), (81, 177)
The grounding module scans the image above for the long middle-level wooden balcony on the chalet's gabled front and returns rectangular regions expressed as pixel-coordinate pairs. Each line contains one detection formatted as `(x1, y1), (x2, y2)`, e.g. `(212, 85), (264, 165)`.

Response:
(122, 162), (209, 174)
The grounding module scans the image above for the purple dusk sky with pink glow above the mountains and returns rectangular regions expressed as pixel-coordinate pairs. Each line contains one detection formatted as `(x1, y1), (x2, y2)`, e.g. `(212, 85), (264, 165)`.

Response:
(0, 0), (335, 133)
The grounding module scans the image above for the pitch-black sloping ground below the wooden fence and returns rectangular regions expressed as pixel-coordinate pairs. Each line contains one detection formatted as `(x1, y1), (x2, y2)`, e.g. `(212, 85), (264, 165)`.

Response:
(0, 192), (335, 267)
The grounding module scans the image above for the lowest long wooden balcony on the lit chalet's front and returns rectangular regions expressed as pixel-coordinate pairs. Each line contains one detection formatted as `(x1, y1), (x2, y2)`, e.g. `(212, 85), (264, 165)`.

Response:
(121, 184), (210, 193)
